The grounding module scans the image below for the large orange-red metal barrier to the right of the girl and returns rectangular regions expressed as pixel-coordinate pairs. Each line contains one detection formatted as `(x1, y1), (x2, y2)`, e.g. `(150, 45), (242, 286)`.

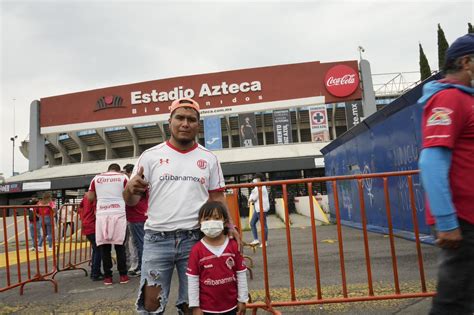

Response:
(226, 171), (435, 314)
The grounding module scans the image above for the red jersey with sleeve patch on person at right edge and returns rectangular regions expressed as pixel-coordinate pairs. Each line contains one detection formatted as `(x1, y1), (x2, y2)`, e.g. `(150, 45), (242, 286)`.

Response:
(422, 82), (474, 223)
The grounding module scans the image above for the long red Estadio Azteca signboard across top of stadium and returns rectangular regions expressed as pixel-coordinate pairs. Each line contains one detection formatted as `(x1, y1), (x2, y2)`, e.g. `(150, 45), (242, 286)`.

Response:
(40, 60), (362, 134)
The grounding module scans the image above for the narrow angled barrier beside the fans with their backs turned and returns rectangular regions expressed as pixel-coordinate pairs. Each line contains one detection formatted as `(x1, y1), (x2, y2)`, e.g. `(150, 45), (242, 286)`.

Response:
(53, 204), (91, 279)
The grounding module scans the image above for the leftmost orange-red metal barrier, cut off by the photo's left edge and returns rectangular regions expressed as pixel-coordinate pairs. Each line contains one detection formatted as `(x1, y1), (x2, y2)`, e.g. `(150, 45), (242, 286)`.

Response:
(0, 206), (58, 295)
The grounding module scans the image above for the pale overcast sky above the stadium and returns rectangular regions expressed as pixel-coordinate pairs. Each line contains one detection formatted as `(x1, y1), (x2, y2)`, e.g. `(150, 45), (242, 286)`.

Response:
(0, 0), (474, 177)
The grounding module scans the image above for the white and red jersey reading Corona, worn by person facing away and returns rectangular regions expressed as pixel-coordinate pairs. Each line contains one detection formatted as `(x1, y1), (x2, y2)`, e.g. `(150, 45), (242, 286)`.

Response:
(89, 172), (128, 214)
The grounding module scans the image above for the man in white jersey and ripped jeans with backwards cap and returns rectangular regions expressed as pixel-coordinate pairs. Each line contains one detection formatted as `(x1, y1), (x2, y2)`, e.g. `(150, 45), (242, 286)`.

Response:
(123, 98), (239, 314)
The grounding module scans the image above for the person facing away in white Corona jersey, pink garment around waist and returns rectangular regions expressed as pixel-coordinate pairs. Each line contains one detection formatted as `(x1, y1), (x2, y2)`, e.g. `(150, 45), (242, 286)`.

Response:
(87, 163), (129, 285)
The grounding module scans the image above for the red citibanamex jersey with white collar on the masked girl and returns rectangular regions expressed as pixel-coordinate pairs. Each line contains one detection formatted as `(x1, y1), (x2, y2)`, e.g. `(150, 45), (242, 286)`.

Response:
(186, 238), (247, 313)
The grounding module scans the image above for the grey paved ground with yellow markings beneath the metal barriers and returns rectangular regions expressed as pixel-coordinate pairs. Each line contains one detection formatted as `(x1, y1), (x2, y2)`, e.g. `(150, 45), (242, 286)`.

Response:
(0, 215), (437, 314)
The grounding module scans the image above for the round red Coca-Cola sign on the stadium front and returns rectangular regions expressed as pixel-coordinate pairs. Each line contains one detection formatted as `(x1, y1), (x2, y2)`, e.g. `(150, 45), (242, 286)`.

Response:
(324, 65), (359, 97)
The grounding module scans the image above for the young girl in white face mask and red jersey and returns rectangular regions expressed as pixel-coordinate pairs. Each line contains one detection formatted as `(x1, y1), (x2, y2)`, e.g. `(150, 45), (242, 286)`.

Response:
(186, 202), (248, 315)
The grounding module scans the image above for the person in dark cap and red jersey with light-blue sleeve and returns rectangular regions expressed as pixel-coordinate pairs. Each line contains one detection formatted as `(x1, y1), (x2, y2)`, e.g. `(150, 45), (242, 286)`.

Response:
(418, 34), (474, 315)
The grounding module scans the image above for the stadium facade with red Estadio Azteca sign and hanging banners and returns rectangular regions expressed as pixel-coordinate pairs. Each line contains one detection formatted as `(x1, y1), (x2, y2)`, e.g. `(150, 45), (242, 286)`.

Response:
(0, 60), (375, 204)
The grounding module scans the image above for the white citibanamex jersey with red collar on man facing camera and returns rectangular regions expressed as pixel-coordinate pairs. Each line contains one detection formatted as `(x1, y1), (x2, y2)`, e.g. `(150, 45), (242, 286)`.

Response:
(132, 141), (225, 231)
